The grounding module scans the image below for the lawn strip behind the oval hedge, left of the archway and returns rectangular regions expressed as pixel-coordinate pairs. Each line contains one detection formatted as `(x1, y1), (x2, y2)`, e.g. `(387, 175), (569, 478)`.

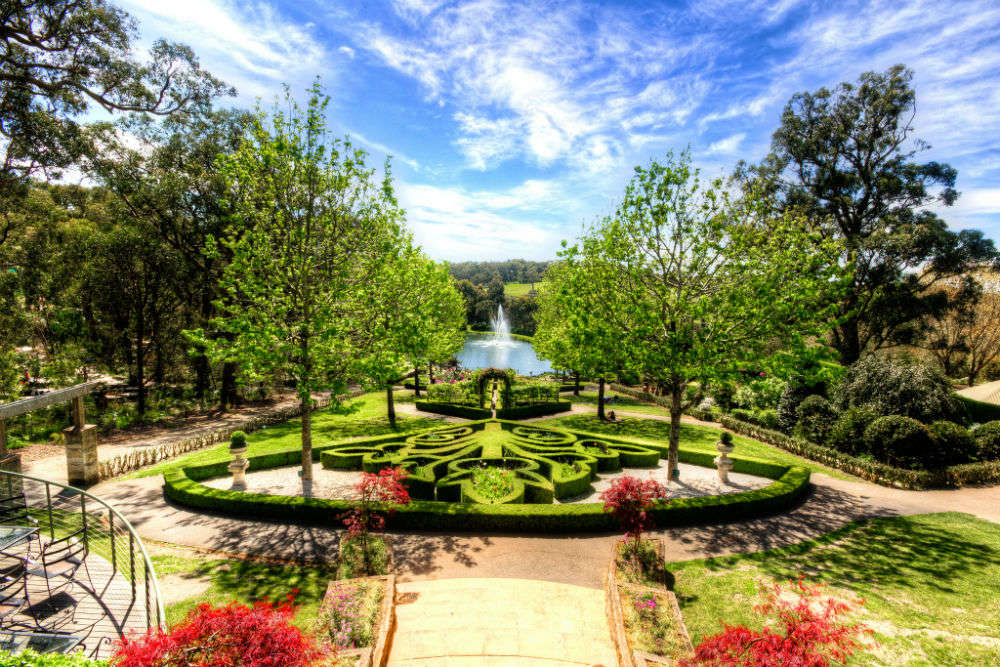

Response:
(132, 392), (442, 477)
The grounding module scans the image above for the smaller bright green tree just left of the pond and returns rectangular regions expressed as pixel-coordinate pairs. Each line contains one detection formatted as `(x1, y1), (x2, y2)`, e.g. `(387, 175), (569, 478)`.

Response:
(357, 245), (465, 428)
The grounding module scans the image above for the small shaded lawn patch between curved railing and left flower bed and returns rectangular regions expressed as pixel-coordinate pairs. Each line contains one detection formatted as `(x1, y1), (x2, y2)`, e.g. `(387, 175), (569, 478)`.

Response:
(151, 556), (337, 629)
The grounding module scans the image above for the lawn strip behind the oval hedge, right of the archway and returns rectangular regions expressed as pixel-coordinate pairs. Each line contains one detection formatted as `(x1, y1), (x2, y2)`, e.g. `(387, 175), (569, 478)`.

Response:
(538, 415), (852, 479)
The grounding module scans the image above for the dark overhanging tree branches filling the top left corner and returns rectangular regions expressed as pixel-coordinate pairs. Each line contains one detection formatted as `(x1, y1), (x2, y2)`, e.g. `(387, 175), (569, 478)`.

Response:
(0, 0), (232, 209)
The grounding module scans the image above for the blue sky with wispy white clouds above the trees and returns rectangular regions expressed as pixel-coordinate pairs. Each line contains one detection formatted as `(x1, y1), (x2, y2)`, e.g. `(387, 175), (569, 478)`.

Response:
(116, 0), (1000, 261)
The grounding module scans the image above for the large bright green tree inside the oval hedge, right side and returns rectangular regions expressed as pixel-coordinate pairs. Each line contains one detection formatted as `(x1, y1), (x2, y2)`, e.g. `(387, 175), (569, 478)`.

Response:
(580, 153), (840, 477)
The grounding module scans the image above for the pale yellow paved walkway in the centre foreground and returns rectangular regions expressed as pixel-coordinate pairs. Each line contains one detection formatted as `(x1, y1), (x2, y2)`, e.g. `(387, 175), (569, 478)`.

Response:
(388, 579), (618, 667)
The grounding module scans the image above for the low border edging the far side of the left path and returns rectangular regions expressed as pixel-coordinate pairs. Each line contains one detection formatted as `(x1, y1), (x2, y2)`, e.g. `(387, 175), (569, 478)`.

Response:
(97, 389), (365, 482)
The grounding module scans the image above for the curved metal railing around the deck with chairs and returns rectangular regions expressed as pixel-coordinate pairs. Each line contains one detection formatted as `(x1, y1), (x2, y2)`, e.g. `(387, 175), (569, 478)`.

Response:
(0, 470), (166, 637)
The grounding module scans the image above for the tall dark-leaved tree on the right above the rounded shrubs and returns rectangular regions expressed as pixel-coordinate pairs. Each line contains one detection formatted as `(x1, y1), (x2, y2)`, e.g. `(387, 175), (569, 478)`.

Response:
(737, 65), (998, 365)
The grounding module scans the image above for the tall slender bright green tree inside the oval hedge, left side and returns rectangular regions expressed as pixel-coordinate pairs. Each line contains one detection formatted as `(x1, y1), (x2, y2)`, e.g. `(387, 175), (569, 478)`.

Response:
(202, 83), (402, 493)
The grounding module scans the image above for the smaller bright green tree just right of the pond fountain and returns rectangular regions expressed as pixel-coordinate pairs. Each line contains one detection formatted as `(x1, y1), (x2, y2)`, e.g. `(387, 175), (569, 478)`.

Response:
(534, 254), (630, 420)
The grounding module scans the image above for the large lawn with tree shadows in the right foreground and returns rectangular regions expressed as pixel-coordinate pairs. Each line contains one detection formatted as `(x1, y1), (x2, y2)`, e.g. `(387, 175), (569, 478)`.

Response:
(667, 513), (1000, 667)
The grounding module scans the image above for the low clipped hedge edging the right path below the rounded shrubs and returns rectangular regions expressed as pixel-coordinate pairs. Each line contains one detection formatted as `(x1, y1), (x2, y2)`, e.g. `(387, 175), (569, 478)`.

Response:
(720, 415), (1000, 489)
